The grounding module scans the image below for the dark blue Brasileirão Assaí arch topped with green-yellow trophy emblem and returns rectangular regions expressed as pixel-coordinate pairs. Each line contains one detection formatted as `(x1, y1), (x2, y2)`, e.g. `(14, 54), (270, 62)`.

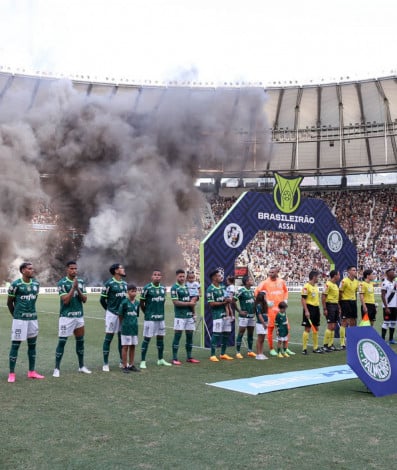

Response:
(200, 174), (357, 347)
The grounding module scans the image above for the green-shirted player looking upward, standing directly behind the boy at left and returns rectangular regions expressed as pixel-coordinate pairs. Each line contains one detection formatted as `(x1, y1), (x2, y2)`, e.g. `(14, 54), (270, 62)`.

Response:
(99, 263), (127, 372)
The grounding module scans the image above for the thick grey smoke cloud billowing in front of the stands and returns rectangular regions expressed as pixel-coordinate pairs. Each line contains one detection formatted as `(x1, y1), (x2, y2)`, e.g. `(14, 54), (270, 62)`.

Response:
(0, 80), (268, 283)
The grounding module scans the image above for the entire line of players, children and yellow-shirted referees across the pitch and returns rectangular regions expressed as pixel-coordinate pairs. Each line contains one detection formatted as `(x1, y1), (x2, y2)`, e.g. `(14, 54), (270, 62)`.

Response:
(3, 261), (397, 383)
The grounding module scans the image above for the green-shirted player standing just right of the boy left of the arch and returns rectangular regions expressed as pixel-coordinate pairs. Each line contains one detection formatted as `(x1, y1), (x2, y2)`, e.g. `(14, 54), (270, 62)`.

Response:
(140, 269), (171, 369)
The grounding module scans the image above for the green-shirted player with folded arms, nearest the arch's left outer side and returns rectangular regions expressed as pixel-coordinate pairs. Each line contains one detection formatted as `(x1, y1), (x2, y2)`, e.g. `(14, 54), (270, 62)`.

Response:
(171, 269), (200, 366)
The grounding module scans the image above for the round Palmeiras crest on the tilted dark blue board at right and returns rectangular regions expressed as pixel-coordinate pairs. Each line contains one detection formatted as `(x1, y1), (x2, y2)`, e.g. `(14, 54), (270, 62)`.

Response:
(357, 339), (391, 382)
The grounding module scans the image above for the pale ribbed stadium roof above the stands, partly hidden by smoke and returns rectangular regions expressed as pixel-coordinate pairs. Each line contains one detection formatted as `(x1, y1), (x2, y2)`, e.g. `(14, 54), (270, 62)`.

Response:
(0, 73), (397, 178)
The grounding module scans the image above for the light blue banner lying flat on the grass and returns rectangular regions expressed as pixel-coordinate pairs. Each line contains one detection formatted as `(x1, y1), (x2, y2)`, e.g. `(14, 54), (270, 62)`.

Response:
(207, 365), (357, 395)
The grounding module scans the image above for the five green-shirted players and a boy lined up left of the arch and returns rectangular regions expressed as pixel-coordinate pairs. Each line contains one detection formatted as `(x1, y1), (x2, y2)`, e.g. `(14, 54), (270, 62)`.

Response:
(2, 261), (200, 383)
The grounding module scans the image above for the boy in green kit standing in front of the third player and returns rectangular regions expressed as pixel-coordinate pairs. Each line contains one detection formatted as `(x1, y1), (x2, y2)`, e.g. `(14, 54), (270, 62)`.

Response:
(119, 284), (140, 374)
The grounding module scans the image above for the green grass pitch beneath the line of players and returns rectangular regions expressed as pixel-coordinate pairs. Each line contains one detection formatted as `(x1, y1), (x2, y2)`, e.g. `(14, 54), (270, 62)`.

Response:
(0, 294), (397, 470)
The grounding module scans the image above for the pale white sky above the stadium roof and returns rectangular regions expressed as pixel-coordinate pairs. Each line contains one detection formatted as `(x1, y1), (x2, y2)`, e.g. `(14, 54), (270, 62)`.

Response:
(0, 0), (397, 83)
